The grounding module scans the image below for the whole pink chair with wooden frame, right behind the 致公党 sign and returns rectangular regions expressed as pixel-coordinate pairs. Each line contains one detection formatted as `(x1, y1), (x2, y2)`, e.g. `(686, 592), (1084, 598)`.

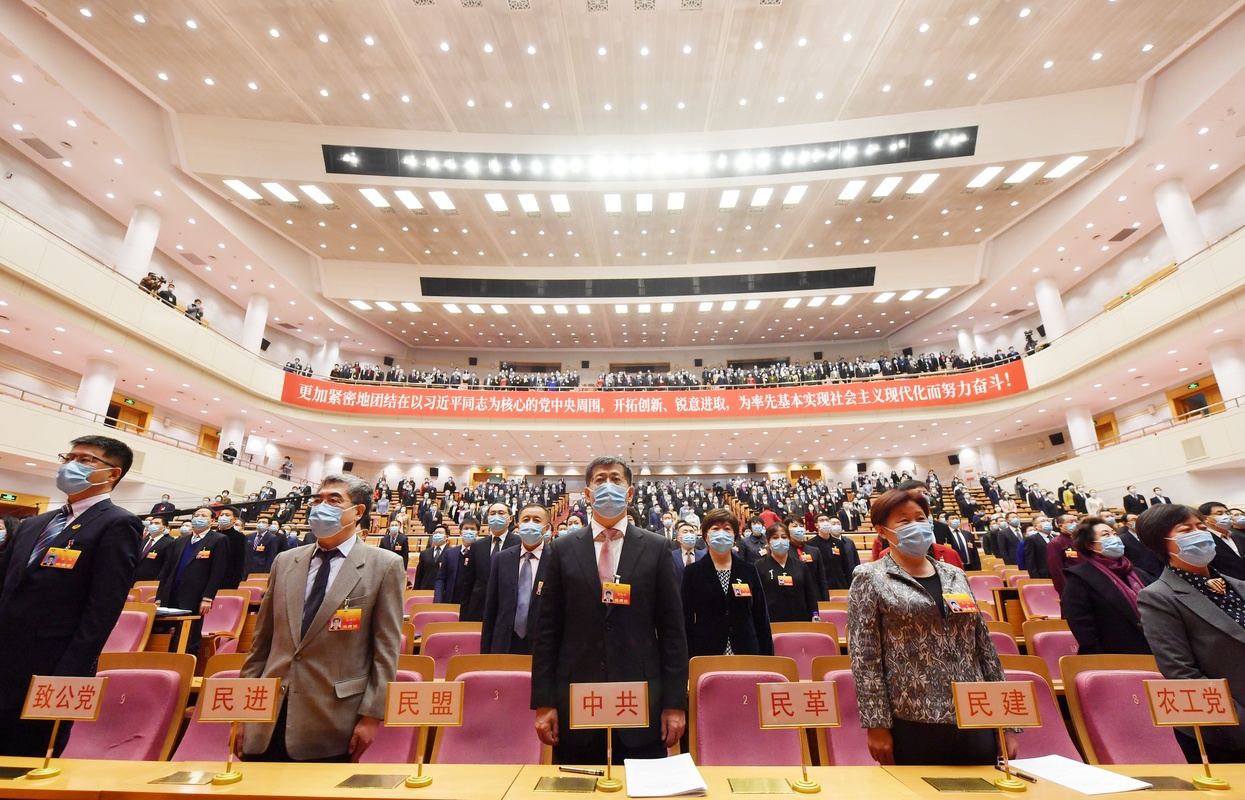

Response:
(63, 653), (194, 761)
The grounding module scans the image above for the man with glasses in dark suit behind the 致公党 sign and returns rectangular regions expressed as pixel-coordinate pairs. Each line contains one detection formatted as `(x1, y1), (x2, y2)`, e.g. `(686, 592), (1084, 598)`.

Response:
(0, 435), (142, 756)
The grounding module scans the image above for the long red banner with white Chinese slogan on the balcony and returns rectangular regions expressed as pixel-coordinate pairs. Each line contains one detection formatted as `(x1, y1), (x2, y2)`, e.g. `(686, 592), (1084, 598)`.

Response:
(281, 361), (1028, 421)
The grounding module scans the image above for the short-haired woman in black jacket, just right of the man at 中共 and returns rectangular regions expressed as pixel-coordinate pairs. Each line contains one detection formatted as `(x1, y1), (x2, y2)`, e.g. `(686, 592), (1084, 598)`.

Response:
(682, 509), (774, 658)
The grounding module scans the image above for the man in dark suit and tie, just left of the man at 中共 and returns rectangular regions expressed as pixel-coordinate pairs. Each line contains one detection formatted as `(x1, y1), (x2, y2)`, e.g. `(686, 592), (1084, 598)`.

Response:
(479, 503), (549, 656)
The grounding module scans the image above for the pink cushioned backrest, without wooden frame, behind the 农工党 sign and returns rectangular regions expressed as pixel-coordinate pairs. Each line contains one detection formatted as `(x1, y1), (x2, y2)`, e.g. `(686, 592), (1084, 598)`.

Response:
(1075, 669), (1185, 764)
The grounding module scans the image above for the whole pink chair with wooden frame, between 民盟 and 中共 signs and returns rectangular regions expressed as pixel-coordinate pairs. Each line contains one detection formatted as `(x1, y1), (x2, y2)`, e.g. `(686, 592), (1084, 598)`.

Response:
(432, 654), (549, 764)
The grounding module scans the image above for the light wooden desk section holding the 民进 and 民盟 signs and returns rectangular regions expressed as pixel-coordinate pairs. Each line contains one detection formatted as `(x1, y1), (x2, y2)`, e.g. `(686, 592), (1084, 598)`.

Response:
(100, 761), (520, 800)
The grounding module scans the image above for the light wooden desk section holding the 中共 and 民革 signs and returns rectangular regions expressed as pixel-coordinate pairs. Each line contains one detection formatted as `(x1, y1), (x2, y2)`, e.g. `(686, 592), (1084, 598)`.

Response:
(505, 764), (916, 800)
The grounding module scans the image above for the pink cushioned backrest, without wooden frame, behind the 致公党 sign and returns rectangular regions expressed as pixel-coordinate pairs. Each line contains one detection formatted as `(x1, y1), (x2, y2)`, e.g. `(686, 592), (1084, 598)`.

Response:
(63, 669), (183, 761)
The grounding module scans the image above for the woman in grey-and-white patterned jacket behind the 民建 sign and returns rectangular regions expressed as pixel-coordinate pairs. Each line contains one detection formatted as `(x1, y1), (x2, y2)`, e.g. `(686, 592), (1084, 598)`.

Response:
(848, 489), (1016, 765)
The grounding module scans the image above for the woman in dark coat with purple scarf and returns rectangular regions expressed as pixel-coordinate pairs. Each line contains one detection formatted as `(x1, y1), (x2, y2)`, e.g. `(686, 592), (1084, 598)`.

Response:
(1059, 516), (1155, 656)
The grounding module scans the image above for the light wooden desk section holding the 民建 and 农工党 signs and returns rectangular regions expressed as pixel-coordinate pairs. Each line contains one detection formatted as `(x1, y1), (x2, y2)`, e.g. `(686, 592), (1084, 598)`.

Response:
(883, 764), (1245, 800)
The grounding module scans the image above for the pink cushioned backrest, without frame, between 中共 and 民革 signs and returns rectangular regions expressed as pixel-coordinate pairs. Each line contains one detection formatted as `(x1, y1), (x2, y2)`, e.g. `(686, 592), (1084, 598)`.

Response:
(692, 671), (801, 766)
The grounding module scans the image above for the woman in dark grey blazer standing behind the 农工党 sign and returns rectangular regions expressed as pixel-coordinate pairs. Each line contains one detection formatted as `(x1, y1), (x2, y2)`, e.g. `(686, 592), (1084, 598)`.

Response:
(1137, 503), (1245, 764)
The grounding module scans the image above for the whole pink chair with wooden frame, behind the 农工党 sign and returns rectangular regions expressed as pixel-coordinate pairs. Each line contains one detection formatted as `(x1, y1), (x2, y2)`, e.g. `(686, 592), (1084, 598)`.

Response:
(1059, 656), (1185, 764)
